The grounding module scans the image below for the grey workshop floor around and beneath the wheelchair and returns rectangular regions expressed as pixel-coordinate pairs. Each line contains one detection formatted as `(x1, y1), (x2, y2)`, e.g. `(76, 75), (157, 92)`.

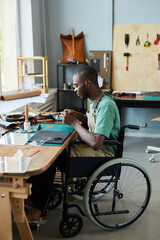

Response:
(13, 137), (160, 240)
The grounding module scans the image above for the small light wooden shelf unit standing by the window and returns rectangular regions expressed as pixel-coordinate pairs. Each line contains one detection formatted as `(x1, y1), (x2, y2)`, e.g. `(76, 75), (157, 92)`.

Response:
(17, 57), (48, 93)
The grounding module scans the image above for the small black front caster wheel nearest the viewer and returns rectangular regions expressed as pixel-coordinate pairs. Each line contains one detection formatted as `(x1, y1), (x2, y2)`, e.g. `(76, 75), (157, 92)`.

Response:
(59, 214), (83, 238)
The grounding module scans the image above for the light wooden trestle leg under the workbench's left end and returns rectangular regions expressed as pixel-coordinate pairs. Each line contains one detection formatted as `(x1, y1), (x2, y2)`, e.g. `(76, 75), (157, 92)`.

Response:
(0, 177), (33, 240)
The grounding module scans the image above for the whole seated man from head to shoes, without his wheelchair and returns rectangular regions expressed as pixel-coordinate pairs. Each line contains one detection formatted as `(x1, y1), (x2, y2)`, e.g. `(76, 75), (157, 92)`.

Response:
(26, 66), (120, 222)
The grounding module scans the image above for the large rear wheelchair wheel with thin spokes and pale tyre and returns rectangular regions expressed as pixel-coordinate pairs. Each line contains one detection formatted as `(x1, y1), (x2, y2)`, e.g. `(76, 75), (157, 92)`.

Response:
(84, 159), (151, 229)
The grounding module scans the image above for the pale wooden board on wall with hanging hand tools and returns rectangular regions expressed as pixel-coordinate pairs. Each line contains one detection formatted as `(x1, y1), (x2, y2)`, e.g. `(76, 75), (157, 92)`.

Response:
(112, 24), (160, 91)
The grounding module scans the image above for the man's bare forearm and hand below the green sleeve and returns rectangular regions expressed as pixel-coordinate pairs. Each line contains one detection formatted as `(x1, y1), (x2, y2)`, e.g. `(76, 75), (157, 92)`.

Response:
(61, 110), (105, 150)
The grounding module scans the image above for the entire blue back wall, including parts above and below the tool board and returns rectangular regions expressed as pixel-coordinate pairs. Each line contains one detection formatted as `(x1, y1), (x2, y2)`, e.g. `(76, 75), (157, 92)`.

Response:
(37, 0), (160, 134)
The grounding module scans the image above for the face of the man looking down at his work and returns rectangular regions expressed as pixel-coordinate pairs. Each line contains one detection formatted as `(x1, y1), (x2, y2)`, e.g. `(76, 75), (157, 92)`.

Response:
(73, 75), (89, 99)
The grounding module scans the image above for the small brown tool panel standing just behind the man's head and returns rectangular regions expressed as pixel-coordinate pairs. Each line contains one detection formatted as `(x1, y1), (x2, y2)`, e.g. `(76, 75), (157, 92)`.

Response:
(89, 51), (112, 92)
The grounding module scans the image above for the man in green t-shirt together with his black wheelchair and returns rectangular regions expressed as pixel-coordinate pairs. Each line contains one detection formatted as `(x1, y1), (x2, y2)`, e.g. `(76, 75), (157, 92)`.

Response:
(26, 66), (150, 237)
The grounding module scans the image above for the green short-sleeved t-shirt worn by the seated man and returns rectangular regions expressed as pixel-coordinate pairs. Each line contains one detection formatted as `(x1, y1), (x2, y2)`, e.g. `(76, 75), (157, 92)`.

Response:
(90, 96), (120, 154)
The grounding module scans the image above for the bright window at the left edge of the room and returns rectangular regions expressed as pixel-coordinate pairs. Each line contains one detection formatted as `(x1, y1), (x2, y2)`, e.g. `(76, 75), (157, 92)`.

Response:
(0, 0), (17, 92)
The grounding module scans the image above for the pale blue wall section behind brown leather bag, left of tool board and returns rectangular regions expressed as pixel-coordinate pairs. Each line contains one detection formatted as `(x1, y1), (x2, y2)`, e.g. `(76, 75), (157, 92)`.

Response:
(45, 0), (112, 87)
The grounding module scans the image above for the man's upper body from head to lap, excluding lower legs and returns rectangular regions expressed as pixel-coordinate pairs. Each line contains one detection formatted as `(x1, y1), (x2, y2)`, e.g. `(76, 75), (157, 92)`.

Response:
(61, 67), (120, 157)
